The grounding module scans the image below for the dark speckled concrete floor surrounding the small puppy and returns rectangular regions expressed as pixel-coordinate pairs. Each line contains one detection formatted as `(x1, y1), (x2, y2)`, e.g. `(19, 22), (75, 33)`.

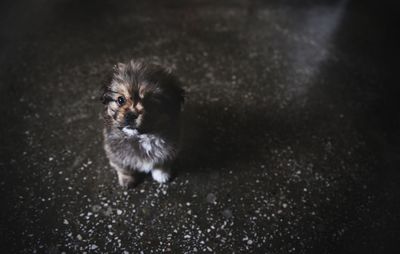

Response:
(0, 0), (400, 253)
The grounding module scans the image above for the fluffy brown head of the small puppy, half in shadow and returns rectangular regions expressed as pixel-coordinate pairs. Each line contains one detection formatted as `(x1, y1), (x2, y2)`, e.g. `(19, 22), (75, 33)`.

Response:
(102, 61), (183, 133)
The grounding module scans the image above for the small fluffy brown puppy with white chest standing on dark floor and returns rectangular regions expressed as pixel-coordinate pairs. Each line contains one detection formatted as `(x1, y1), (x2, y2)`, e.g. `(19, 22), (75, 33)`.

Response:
(101, 60), (184, 187)
